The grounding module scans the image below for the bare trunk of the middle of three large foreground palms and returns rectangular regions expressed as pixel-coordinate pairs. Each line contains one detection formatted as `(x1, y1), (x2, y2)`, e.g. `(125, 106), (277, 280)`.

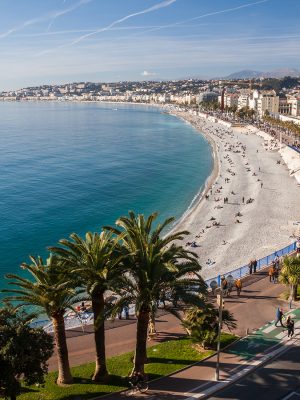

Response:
(92, 293), (108, 382)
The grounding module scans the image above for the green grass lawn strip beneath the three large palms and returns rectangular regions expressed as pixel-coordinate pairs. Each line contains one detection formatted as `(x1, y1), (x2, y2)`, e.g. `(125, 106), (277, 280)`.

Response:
(18, 333), (236, 400)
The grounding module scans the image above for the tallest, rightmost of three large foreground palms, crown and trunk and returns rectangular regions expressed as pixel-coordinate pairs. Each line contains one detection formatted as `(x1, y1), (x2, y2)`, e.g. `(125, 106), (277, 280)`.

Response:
(107, 211), (206, 374)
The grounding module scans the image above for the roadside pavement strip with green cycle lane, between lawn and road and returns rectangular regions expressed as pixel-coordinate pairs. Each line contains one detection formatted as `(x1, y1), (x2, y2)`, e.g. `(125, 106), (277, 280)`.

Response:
(105, 309), (300, 400)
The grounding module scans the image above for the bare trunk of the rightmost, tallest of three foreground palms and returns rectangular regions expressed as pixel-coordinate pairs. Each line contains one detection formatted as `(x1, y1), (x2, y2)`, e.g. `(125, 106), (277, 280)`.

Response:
(132, 310), (150, 375)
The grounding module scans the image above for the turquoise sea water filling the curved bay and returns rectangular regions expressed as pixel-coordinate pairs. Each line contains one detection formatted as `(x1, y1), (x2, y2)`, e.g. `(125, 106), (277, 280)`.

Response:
(0, 102), (213, 288)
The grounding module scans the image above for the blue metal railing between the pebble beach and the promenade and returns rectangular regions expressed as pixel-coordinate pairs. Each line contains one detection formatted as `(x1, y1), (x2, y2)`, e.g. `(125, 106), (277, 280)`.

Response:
(205, 242), (296, 287)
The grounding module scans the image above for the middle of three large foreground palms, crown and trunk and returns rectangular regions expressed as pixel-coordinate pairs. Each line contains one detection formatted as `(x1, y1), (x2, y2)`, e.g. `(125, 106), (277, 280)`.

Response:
(49, 231), (122, 382)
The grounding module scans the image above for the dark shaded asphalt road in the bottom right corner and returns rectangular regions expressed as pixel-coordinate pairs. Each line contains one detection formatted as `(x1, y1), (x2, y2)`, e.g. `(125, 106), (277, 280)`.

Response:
(209, 339), (300, 400)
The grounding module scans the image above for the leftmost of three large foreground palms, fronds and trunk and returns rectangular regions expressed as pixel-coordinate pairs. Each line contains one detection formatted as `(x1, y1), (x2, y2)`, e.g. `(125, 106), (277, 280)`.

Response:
(3, 256), (78, 384)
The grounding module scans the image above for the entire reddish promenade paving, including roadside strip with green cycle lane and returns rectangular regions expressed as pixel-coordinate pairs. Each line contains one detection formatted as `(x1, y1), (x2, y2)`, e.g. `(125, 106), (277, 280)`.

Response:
(47, 271), (300, 400)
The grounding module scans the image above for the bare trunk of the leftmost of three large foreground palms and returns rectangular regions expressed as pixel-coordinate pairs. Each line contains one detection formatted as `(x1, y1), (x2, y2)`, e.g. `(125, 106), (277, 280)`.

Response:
(52, 314), (73, 385)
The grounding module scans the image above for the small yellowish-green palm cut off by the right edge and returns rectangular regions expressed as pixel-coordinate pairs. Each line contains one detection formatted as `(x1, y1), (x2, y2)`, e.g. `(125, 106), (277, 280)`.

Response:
(279, 257), (300, 300)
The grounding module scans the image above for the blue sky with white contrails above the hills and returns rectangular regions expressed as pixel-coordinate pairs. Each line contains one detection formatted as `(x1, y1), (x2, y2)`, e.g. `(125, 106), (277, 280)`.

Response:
(0, 0), (300, 91)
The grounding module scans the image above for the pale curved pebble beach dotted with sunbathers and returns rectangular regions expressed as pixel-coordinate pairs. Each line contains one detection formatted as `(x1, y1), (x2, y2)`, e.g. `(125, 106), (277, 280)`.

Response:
(172, 110), (300, 279)
